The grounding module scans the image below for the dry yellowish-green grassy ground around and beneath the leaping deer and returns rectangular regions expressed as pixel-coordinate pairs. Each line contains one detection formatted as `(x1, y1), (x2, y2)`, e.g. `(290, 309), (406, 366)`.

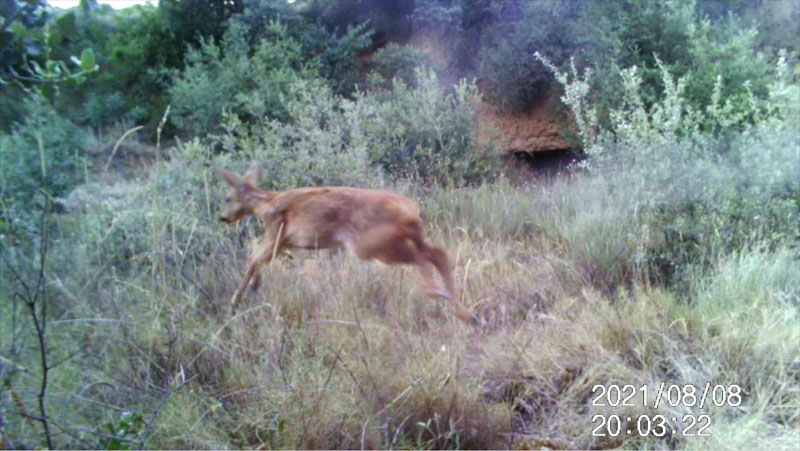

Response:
(0, 165), (800, 449)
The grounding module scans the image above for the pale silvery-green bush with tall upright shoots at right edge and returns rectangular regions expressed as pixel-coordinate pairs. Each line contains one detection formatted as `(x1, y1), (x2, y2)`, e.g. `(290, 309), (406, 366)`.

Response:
(543, 47), (800, 288)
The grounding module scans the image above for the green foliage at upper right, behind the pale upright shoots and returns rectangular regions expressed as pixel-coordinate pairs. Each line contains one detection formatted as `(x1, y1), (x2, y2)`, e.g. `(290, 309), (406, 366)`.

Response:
(580, 0), (770, 127)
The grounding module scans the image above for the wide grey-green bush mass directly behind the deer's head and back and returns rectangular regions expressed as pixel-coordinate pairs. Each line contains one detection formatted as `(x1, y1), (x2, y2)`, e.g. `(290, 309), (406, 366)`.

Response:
(221, 70), (497, 188)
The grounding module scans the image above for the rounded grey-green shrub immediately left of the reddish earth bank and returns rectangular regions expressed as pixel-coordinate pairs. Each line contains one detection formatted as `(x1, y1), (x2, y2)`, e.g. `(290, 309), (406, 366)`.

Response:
(354, 68), (498, 185)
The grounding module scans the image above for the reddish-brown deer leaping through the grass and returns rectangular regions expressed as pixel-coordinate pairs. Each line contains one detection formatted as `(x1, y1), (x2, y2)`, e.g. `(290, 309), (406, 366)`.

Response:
(216, 164), (479, 325)
